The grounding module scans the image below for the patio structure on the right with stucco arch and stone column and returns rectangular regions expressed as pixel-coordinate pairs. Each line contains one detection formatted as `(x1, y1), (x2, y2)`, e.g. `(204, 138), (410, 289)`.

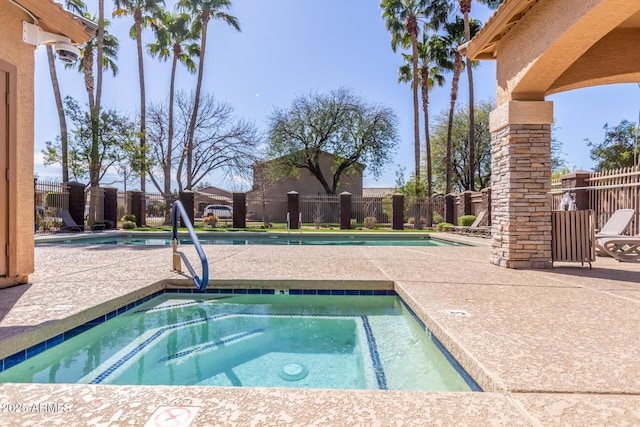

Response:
(466, 0), (640, 268)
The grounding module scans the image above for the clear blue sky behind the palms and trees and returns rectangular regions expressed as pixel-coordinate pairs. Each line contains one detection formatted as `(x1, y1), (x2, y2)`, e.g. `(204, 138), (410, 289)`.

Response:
(35, 0), (640, 191)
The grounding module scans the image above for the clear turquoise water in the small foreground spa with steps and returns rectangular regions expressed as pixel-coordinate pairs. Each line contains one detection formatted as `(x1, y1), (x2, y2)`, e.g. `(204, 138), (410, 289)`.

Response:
(0, 294), (474, 391)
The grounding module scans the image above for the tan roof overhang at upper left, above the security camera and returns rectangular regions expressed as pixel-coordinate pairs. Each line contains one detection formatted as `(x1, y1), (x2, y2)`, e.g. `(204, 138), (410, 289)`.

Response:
(9, 0), (97, 45)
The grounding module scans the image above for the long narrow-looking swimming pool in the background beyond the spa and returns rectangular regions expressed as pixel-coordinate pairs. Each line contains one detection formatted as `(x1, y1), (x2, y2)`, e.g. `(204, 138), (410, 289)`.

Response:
(36, 232), (460, 246)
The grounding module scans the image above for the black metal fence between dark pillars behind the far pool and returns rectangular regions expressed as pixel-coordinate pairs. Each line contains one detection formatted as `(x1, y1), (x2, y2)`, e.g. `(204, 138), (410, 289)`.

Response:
(34, 179), (452, 234)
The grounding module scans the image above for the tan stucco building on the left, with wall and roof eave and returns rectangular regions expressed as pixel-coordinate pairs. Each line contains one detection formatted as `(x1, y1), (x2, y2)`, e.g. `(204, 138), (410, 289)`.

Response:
(0, 0), (93, 287)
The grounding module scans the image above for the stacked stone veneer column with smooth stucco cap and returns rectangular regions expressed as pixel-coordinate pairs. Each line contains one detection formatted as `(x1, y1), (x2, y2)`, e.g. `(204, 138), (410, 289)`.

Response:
(490, 101), (553, 268)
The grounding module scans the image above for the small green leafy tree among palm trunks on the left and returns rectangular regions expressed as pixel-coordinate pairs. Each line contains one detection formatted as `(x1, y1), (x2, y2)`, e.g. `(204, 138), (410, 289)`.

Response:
(42, 97), (136, 187)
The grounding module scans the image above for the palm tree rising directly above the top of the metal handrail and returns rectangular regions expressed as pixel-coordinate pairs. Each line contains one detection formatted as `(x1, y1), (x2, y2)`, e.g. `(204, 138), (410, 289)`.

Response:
(149, 12), (200, 195)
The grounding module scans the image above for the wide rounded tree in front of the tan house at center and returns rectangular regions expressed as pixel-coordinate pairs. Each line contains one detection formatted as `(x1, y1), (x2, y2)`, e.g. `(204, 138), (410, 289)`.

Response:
(267, 89), (398, 194)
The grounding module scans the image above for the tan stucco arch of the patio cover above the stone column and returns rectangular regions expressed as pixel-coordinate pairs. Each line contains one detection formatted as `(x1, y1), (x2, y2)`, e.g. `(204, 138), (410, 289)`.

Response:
(496, 0), (640, 105)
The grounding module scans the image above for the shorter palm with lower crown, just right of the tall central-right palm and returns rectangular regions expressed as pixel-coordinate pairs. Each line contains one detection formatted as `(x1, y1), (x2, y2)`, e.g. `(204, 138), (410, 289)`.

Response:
(398, 32), (450, 224)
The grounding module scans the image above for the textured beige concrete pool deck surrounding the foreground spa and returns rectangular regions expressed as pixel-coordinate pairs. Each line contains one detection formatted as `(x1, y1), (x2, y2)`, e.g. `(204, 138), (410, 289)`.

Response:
(0, 234), (640, 426)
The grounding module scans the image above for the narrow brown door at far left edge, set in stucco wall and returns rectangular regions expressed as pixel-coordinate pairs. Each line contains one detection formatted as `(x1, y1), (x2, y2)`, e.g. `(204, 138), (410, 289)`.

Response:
(0, 71), (9, 277)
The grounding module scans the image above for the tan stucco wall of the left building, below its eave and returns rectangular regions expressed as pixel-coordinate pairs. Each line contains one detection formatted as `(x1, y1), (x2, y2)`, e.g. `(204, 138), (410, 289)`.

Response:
(0, 2), (34, 286)
